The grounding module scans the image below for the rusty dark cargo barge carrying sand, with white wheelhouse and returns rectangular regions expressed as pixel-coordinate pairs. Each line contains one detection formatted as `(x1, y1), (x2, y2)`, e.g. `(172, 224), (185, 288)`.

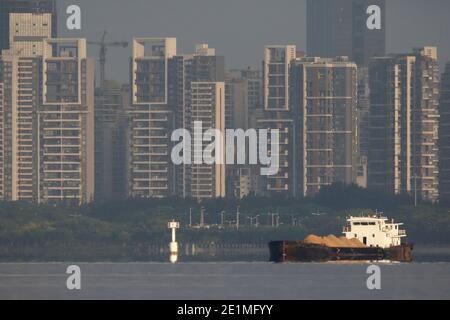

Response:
(269, 215), (413, 262)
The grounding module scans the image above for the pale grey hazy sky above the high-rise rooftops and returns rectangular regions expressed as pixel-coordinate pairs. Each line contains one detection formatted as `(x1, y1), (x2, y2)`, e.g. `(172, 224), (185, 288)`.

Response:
(57, 0), (450, 82)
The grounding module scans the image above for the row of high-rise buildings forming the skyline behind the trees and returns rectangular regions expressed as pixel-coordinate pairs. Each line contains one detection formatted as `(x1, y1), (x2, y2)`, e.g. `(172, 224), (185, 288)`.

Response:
(0, 0), (446, 204)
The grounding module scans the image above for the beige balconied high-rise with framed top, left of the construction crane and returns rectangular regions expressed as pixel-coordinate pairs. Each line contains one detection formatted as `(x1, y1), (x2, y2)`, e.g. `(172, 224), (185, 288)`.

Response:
(38, 39), (95, 205)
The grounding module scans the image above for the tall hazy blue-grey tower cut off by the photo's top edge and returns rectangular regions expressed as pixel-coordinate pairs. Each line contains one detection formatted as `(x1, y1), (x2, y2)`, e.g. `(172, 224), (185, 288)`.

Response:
(307, 0), (386, 65)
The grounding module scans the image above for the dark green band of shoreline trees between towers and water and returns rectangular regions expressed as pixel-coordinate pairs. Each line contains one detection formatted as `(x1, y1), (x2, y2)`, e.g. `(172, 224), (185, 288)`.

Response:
(0, 184), (450, 262)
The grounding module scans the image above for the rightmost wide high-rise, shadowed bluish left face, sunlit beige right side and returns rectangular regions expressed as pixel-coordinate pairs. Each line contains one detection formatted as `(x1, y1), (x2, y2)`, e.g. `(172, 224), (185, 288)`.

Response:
(368, 47), (440, 202)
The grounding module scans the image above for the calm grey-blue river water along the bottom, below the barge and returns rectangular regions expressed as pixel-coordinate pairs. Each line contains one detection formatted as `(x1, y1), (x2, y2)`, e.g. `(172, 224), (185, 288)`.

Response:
(0, 249), (450, 300)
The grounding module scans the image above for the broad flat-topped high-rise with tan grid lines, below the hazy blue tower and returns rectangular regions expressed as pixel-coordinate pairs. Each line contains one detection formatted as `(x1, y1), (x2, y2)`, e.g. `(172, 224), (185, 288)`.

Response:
(290, 57), (357, 196)
